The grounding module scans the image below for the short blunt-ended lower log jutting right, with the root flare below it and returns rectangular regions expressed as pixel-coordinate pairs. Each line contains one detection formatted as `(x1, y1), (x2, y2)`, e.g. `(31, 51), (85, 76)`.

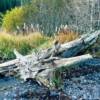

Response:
(35, 54), (93, 87)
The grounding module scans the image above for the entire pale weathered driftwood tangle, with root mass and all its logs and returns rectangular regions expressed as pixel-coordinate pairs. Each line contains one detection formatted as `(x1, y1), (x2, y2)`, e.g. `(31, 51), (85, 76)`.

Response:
(0, 31), (100, 86)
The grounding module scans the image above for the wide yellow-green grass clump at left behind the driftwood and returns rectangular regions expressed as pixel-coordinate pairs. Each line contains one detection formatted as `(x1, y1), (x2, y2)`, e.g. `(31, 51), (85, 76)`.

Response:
(0, 33), (49, 60)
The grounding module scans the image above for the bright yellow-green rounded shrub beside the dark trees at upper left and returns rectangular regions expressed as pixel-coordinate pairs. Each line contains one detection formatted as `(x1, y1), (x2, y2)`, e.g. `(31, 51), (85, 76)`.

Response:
(2, 7), (25, 32)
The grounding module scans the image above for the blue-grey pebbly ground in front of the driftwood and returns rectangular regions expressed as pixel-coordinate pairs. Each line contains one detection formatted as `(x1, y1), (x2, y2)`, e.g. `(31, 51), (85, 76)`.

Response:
(0, 61), (100, 100)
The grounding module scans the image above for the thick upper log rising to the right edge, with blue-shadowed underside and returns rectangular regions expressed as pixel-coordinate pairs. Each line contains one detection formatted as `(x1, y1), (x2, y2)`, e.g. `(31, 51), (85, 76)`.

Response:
(38, 30), (100, 59)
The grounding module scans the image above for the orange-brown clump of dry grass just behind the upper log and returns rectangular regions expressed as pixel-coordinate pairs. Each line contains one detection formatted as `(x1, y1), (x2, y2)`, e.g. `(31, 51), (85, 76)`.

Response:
(55, 30), (78, 43)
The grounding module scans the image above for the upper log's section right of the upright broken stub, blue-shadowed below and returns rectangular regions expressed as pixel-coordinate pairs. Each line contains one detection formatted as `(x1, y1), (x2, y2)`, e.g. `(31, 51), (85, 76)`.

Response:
(59, 31), (100, 57)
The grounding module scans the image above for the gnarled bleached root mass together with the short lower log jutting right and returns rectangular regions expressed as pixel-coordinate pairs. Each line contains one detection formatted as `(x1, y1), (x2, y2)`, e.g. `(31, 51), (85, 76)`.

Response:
(13, 54), (92, 87)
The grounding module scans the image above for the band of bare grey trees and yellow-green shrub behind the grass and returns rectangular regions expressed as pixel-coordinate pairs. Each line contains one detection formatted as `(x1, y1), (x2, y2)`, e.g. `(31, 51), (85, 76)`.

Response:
(3, 0), (100, 35)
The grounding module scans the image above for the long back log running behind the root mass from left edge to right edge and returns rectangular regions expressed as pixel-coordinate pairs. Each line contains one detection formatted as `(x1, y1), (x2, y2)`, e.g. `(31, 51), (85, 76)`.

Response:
(0, 30), (100, 67)
